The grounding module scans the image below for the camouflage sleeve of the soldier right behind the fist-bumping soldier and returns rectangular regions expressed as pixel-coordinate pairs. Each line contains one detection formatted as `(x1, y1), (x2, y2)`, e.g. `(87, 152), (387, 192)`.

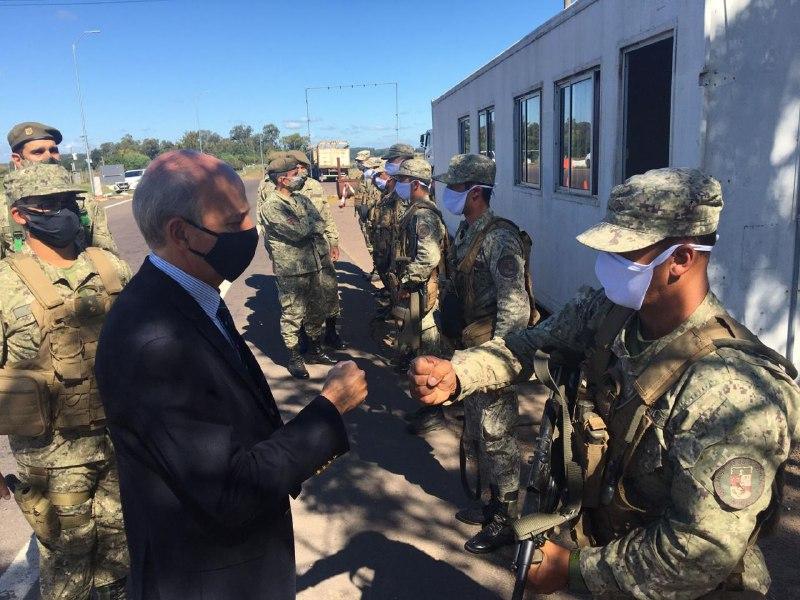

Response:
(482, 227), (530, 337)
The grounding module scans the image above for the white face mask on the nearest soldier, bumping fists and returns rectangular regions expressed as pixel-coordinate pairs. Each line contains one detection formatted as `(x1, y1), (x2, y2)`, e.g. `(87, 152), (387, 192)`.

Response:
(594, 244), (713, 310)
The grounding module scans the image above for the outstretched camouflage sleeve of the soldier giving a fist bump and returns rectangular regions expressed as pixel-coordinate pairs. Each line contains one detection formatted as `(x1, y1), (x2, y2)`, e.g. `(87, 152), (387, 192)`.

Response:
(452, 288), (611, 399)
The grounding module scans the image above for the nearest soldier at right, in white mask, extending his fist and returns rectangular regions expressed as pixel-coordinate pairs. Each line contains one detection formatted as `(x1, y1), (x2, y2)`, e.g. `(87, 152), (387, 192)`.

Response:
(412, 169), (800, 600)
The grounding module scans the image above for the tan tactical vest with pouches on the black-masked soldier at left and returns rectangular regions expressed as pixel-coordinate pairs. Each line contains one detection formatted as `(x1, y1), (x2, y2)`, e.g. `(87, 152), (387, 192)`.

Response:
(9, 248), (122, 430)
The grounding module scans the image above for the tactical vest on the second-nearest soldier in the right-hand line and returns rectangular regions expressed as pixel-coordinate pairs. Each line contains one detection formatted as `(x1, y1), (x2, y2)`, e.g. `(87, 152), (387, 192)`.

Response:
(454, 217), (539, 347)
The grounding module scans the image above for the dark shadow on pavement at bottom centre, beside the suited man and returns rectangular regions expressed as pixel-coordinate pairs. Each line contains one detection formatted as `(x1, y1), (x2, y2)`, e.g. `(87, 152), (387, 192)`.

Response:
(297, 531), (500, 600)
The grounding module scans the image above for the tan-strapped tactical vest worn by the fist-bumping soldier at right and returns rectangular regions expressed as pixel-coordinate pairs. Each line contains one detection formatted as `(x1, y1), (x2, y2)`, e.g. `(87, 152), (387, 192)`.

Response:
(573, 305), (797, 545)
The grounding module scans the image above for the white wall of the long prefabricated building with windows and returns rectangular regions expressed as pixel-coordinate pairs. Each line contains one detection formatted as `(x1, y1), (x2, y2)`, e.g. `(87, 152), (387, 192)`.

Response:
(432, 0), (800, 352)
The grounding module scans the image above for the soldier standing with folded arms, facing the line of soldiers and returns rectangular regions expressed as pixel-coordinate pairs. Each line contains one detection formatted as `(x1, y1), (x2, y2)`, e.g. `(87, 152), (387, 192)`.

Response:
(258, 155), (334, 379)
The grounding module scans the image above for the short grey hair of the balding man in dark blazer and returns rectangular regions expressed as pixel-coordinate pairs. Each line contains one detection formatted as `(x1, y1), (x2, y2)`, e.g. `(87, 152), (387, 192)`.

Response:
(133, 156), (203, 250)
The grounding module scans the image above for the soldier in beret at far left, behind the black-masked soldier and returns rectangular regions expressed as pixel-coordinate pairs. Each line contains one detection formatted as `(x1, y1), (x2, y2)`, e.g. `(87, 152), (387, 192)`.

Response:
(0, 121), (119, 258)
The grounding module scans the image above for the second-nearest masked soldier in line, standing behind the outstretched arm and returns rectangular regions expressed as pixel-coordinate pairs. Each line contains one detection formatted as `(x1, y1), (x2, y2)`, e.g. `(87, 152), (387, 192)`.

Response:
(435, 154), (533, 553)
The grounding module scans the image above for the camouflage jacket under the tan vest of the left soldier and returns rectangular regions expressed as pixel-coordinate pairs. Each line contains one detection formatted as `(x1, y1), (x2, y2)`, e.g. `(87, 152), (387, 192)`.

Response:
(0, 245), (131, 468)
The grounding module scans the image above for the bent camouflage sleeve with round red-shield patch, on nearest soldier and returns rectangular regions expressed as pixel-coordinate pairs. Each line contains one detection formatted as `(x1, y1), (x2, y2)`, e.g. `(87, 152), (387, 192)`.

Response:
(580, 349), (800, 600)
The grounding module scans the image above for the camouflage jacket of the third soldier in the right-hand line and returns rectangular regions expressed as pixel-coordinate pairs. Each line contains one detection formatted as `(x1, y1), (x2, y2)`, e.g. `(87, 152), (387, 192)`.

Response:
(399, 200), (447, 287)
